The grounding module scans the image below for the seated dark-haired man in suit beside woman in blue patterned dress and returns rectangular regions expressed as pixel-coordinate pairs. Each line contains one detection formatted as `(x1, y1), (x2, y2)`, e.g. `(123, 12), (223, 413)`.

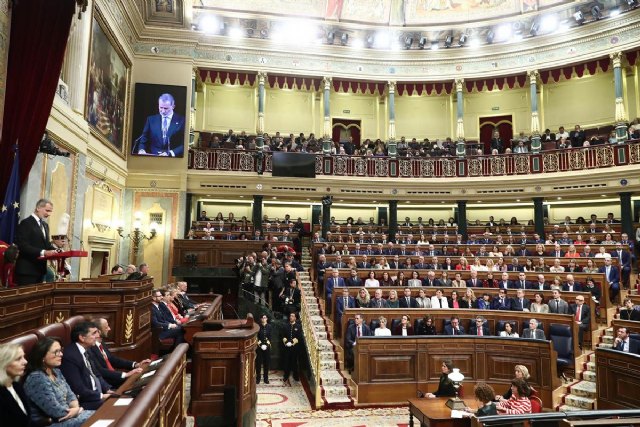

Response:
(60, 322), (112, 409)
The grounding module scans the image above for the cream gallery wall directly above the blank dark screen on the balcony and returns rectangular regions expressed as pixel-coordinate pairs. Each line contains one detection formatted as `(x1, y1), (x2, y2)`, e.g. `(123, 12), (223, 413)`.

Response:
(264, 89), (314, 135)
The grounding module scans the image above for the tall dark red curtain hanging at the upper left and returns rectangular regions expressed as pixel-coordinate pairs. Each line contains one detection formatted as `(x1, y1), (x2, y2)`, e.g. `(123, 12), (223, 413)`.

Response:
(0, 0), (76, 194)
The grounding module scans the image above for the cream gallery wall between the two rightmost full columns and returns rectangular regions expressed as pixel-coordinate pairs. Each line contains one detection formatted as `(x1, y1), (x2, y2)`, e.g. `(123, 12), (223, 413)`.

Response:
(540, 72), (615, 132)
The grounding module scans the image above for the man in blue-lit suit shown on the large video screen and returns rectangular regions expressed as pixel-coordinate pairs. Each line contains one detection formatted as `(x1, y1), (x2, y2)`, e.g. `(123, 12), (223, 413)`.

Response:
(134, 93), (184, 157)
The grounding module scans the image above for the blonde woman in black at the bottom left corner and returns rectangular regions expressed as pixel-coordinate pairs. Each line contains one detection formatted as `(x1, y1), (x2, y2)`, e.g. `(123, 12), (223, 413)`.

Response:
(0, 343), (32, 426)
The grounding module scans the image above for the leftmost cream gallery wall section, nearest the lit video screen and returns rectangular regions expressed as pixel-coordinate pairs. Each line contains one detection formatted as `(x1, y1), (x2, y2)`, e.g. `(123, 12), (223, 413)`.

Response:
(195, 84), (258, 134)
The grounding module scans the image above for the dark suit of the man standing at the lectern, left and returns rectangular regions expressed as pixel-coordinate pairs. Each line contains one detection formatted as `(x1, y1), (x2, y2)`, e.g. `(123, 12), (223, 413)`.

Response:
(15, 215), (55, 285)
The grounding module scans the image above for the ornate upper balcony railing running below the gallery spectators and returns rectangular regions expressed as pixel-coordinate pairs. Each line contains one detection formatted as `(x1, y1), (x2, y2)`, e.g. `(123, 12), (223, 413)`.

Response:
(189, 140), (640, 178)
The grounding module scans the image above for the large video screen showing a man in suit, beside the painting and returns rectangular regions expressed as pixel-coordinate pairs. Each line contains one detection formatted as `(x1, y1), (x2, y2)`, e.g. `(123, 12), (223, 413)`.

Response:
(131, 83), (187, 157)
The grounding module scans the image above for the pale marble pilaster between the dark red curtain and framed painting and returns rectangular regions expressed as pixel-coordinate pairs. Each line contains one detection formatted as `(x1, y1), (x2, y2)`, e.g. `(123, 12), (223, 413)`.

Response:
(62, 1), (92, 115)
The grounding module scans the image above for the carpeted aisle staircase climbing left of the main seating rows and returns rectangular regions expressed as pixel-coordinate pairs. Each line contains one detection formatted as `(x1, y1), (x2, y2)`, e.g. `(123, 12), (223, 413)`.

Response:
(299, 248), (353, 409)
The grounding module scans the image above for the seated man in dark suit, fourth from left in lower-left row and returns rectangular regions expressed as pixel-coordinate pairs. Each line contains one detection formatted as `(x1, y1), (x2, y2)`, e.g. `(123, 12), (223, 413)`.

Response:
(89, 317), (151, 388)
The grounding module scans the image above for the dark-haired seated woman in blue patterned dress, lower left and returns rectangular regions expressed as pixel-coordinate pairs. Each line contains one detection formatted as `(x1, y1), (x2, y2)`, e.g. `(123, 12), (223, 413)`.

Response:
(24, 337), (94, 427)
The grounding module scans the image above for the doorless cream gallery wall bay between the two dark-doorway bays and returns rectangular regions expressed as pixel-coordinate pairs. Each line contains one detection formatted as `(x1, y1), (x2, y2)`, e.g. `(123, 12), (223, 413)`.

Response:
(395, 95), (451, 140)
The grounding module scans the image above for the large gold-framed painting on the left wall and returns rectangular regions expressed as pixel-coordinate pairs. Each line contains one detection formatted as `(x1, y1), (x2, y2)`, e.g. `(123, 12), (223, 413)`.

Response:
(84, 7), (131, 158)
